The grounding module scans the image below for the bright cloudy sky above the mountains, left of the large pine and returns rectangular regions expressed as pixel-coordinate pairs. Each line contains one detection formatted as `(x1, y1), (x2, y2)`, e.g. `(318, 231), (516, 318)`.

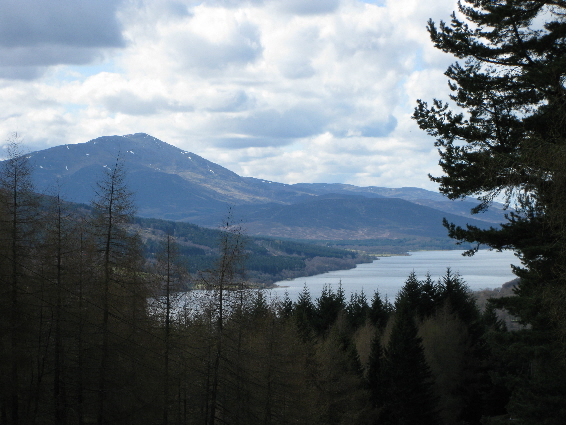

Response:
(0, 0), (462, 190)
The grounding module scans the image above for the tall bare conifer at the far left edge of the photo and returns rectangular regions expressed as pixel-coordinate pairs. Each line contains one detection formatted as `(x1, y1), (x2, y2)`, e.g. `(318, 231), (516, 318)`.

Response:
(0, 135), (39, 425)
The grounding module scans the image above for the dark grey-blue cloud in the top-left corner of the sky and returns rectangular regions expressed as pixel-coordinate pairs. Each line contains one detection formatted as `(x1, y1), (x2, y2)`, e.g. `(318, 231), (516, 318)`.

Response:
(0, 0), (124, 80)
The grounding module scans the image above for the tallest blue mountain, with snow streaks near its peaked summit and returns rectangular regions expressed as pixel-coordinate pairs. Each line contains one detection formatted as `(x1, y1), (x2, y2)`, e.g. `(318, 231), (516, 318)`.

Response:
(29, 134), (284, 220)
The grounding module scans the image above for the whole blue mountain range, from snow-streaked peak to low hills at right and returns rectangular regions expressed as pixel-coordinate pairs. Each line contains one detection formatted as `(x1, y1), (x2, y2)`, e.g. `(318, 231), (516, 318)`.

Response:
(24, 133), (502, 239)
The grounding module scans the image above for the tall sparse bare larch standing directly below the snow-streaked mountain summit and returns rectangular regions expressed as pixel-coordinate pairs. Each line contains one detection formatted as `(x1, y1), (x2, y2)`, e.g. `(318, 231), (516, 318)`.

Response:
(90, 157), (153, 424)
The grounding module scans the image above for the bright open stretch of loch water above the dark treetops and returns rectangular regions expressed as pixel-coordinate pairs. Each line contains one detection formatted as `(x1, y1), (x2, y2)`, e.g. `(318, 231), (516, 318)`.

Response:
(271, 250), (520, 301)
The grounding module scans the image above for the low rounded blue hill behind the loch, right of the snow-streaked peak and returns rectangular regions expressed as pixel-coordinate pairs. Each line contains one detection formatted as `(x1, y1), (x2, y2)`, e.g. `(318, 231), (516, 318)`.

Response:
(229, 195), (494, 240)
